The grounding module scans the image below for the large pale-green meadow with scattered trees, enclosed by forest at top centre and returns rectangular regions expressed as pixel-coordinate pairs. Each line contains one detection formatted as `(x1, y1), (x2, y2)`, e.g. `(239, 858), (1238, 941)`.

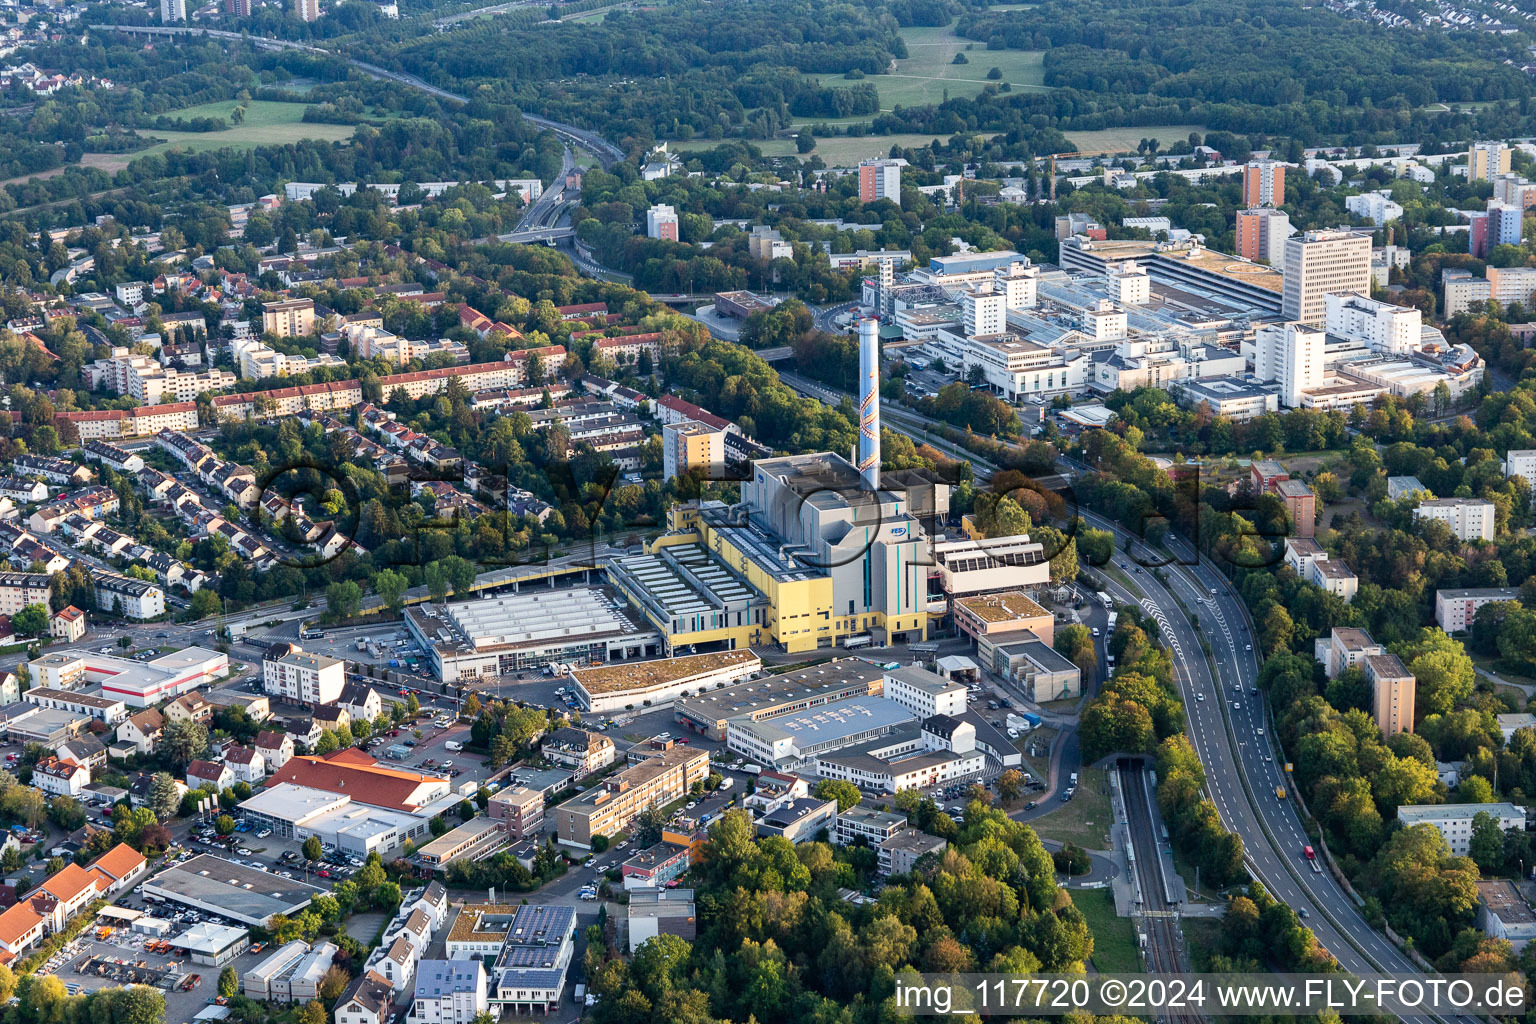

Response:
(816, 26), (1046, 111)
